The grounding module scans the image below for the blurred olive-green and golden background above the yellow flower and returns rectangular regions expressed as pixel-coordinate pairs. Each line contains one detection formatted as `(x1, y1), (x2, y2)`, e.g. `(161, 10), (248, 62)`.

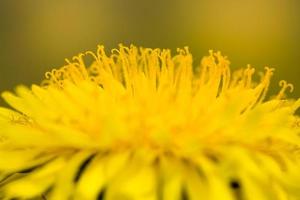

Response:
(0, 0), (300, 100)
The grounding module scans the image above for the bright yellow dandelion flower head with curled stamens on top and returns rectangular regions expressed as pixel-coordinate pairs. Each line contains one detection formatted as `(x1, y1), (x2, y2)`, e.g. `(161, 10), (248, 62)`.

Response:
(0, 45), (300, 200)
